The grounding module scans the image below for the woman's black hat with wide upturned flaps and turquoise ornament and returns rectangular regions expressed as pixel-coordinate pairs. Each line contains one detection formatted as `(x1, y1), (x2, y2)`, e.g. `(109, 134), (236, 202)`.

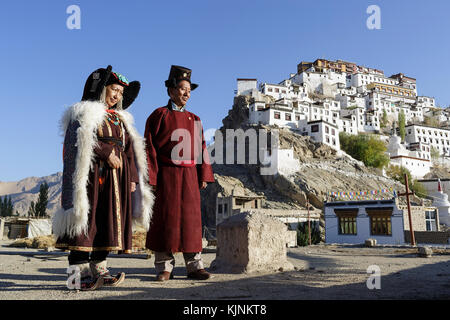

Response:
(81, 66), (141, 110)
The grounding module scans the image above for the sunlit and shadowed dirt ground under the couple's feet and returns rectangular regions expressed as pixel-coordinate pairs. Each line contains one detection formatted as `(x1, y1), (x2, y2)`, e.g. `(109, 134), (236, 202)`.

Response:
(0, 241), (450, 300)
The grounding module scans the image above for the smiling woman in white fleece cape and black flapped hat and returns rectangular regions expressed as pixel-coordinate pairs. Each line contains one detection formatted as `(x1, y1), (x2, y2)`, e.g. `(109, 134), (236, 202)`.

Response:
(53, 66), (153, 290)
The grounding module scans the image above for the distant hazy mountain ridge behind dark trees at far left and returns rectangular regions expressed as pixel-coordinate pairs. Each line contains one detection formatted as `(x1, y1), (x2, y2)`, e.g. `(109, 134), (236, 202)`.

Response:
(0, 172), (62, 216)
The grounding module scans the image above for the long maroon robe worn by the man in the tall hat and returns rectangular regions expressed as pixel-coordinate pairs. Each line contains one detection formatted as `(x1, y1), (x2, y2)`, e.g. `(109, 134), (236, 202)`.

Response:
(144, 100), (214, 252)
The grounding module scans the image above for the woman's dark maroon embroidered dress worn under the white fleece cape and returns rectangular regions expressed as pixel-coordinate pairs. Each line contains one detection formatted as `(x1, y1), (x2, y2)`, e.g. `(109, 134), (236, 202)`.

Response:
(56, 110), (139, 253)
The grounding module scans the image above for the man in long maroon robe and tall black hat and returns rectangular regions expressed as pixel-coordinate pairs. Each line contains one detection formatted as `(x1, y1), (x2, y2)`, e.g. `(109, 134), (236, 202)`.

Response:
(145, 66), (214, 281)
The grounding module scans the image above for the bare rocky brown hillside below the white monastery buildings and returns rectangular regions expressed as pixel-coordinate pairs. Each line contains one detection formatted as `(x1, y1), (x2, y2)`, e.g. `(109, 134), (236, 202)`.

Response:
(202, 96), (426, 225)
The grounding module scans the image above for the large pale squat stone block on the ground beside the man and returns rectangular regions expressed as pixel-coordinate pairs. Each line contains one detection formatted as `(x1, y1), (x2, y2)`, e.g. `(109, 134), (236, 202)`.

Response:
(211, 211), (294, 273)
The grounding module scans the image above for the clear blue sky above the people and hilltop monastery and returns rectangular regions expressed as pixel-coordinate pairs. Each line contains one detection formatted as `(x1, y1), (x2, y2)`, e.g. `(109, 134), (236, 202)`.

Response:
(0, 0), (450, 181)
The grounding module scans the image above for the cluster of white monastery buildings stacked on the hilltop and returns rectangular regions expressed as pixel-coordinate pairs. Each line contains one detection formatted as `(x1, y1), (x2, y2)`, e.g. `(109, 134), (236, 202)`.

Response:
(235, 59), (450, 157)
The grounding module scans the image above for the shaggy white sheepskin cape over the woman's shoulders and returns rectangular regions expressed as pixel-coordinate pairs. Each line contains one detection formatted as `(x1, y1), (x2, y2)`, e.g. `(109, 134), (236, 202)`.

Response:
(52, 101), (154, 238)
